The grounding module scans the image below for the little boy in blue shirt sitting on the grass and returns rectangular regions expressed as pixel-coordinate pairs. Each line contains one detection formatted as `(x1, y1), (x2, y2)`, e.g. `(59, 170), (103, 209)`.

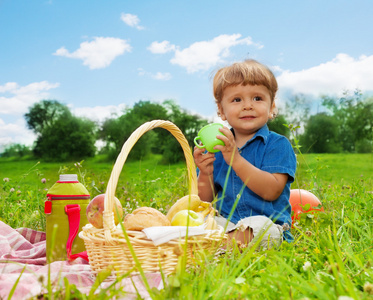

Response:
(193, 60), (296, 248)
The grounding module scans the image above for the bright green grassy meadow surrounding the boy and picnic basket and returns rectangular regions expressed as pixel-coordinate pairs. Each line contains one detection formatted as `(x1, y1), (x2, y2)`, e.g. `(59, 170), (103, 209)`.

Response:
(0, 154), (373, 300)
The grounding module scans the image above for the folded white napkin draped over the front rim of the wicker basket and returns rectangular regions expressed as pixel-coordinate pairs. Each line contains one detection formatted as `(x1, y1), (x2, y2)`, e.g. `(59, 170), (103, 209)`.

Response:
(142, 224), (209, 246)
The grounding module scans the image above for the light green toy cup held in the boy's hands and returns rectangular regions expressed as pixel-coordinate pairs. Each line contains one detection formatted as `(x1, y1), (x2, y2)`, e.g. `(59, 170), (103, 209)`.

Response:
(194, 123), (224, 153)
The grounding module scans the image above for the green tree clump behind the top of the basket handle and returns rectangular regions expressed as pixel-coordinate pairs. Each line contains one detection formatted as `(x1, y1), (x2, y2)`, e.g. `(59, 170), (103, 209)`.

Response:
(99, 100), (207, 163)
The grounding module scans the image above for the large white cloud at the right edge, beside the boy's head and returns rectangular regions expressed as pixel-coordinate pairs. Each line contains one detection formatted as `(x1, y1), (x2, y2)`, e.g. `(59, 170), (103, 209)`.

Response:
(277, 53), (373, 96)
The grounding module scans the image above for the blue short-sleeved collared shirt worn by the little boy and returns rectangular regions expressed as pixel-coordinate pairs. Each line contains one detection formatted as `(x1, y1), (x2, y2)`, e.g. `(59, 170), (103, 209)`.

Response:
(214, 125), (296, 233)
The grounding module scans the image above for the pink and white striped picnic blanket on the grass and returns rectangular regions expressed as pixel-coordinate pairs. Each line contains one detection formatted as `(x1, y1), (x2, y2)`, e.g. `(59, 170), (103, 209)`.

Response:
(0, 221), (163, 299)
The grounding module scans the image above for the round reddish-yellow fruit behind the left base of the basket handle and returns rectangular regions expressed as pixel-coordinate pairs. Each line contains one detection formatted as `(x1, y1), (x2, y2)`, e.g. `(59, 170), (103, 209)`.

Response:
(86, 194), (123, 228)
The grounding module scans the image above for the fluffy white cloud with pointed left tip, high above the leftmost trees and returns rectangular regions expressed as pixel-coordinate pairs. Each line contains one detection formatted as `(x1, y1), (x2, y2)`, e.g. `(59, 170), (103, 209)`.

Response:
(53, 37), (132, 69)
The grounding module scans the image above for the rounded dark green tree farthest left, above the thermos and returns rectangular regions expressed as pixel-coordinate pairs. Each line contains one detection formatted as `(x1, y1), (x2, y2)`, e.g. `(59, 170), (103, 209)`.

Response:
(25, 100), (96, 161)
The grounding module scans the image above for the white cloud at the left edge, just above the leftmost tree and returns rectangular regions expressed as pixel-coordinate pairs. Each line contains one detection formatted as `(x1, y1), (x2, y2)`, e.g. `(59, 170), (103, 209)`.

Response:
(0, 81), (59, 115)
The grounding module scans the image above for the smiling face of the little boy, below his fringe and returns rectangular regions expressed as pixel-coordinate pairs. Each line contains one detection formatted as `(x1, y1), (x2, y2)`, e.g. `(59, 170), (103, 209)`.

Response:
(218, 84), (275, 138)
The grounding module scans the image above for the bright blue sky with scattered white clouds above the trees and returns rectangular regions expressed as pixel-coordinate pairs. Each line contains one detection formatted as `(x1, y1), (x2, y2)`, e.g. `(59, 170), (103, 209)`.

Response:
(0, 0), (373, 149)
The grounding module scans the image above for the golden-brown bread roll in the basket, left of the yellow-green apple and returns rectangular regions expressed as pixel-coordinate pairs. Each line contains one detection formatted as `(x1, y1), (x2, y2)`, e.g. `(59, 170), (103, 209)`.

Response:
(123, 207), (171, 230)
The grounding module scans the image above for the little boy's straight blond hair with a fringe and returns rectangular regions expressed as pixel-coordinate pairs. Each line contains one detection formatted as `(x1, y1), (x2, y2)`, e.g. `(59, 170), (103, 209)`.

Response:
(213, 59), (278, 103)
